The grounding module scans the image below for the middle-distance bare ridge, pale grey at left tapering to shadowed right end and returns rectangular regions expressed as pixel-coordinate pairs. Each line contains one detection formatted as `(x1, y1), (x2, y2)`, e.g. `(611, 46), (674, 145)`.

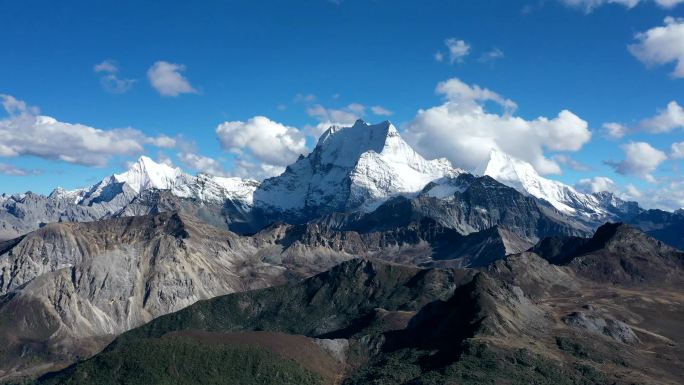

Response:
(0, 207), (552, 377)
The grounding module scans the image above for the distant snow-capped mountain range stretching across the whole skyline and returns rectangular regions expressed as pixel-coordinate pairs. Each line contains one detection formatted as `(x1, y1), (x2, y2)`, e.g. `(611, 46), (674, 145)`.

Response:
(0, 121), (684, 246)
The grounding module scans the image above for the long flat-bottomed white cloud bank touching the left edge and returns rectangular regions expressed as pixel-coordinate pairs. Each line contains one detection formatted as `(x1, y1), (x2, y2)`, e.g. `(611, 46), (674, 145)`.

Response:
(0, 95), (174, 166)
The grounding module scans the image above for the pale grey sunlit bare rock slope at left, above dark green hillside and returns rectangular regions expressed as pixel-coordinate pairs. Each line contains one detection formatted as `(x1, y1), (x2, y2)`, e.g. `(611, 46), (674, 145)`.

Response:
(0, 213), (312, 375)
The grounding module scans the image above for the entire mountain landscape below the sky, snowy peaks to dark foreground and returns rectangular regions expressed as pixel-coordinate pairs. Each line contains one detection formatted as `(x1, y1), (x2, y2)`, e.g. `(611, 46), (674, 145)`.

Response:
(0, 120), (684, 384)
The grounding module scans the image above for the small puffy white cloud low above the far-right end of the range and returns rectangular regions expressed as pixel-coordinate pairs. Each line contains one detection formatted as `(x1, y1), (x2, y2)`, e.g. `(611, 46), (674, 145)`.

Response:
(606, 142), (667, 182)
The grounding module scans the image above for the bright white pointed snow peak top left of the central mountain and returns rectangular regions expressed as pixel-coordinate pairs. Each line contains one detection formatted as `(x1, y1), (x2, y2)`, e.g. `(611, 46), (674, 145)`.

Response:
(113, 156), (187, 194)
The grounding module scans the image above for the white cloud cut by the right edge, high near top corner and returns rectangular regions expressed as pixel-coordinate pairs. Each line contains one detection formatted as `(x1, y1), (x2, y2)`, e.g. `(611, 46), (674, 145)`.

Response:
(628, 17), (684, 78)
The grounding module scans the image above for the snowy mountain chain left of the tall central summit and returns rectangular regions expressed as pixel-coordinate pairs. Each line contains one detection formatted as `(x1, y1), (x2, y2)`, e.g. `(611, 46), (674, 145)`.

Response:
(0, 156), (259, 240)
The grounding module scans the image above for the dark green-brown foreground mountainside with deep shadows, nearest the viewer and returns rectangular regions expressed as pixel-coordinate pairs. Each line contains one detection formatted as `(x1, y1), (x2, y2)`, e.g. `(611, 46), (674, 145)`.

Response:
(39, 254), (684, 385)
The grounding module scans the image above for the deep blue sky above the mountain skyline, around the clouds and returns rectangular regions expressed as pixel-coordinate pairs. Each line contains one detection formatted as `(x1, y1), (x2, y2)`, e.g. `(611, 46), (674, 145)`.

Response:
(0, 0), (684, 208)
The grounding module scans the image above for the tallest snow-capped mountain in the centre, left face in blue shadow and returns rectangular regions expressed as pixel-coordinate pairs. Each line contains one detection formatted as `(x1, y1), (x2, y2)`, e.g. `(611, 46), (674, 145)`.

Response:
(254, 120), (462, 216)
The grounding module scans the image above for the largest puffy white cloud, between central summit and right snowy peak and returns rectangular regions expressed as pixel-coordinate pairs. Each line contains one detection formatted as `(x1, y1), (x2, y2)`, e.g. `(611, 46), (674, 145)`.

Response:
(406, 79), (591, 174)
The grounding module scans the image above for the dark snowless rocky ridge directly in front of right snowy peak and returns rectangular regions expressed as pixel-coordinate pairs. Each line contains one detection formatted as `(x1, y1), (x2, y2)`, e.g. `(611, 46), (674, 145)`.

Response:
(314, 174), (591, 243)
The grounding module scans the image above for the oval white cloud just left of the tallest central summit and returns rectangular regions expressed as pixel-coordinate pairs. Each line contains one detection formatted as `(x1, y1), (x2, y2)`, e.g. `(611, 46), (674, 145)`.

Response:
(216, 116), (308, 166)
